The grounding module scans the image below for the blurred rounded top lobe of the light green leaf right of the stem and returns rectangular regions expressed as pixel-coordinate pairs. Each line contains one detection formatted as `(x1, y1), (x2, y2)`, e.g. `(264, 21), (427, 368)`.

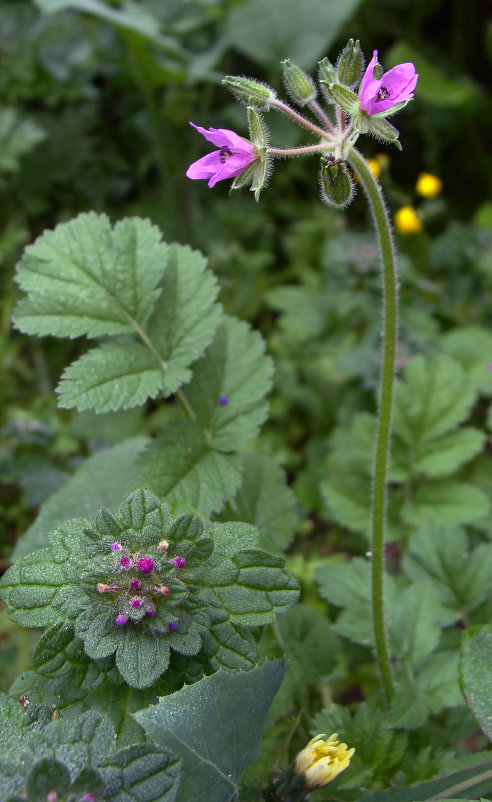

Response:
(393, 354), (476, 447)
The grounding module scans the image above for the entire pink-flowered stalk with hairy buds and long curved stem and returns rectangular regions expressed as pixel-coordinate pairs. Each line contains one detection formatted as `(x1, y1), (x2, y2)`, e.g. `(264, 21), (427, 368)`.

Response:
(188, 39), (418, 700)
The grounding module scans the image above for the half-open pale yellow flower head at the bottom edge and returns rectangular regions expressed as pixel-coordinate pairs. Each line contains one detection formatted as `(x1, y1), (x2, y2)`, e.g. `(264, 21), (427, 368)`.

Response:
(294, 732), (355, 789)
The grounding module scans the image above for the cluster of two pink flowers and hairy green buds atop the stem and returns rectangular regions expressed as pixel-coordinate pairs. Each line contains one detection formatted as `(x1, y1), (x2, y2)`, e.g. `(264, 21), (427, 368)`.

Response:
(186, 39), (418, 209)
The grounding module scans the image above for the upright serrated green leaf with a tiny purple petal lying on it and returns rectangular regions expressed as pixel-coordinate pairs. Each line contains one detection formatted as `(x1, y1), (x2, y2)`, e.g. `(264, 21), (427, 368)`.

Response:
(186, 317), (273, 451)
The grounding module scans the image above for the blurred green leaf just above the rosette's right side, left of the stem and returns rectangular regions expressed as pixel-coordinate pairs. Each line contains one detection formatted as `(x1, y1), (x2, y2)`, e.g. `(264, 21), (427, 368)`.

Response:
(221, 453), (298, 553)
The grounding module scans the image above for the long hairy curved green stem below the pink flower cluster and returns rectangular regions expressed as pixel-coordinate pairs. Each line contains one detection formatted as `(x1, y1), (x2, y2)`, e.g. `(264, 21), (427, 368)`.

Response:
(347, 148), (398, 701)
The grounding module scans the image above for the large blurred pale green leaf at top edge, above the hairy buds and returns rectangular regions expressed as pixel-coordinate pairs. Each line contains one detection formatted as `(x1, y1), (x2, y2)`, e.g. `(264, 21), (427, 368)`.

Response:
(227, 0), (359, 67)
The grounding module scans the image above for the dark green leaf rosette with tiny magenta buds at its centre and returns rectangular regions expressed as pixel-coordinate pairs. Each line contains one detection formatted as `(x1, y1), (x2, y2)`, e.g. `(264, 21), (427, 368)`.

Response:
(0, 490), (298, 688)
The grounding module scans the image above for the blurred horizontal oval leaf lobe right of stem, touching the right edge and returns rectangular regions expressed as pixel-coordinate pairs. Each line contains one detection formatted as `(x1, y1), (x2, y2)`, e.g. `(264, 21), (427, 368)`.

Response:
(402, 479), (490, 527)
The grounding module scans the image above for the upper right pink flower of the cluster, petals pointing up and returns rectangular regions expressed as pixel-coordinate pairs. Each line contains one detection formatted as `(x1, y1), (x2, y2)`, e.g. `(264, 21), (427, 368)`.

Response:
(359, 50), (419, 115)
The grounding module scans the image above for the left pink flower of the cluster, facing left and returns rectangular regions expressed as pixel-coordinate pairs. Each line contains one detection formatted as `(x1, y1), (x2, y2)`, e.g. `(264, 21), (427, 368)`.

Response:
(186, 122), (258, 187)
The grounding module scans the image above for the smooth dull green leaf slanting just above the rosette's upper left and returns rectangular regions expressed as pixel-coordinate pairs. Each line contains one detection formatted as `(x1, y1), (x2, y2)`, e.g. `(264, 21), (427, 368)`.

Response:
(14, 437), (147, 559)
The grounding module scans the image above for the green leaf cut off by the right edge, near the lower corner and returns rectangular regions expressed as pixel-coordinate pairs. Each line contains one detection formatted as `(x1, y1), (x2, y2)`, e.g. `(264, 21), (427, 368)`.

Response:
(460, 624), (492, 740)
